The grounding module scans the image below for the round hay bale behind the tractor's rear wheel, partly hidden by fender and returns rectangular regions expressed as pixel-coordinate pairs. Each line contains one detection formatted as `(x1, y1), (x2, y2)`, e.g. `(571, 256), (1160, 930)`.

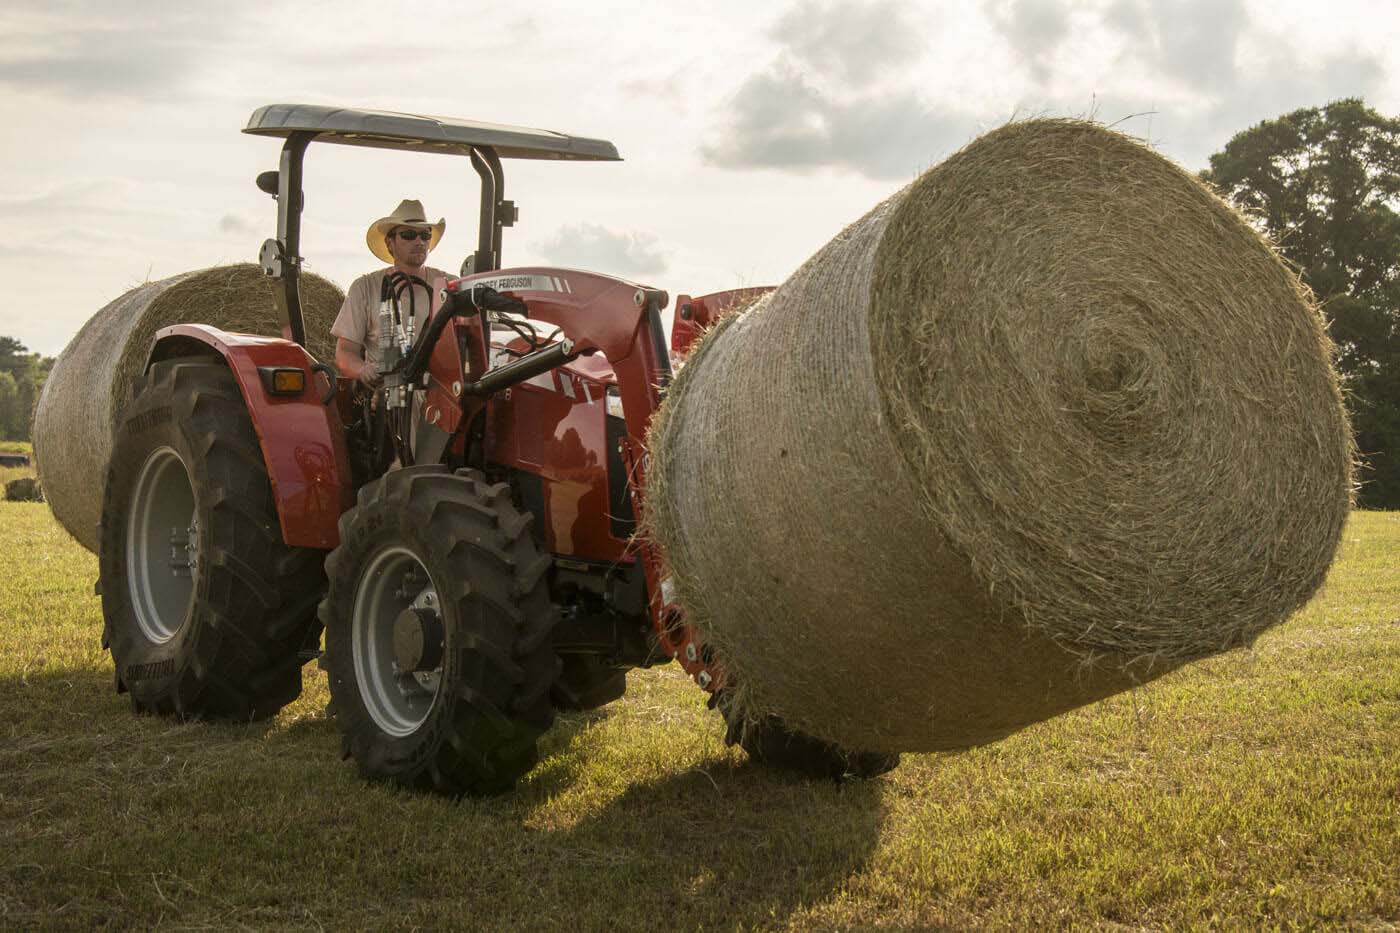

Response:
(34, 262), (344, 551)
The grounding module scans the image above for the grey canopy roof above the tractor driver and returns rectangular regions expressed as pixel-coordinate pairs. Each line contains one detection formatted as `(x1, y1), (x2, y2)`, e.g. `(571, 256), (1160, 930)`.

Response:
(244, 104), (620, 161)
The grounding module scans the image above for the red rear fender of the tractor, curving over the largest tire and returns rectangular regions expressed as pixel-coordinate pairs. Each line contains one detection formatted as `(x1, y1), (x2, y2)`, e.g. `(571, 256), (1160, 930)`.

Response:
(146, 324), (354, 549)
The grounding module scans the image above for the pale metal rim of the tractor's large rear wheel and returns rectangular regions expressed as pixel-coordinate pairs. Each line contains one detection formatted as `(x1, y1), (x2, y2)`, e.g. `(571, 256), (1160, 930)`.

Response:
(126, 447), (200, 644)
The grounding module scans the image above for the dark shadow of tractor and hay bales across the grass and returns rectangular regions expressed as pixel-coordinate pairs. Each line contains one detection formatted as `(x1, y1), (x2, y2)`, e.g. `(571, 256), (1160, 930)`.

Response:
(0, 670), (885, 929)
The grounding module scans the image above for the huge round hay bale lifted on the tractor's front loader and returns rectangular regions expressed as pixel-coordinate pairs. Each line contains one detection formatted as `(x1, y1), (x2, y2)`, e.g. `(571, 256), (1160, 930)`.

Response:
(647, 120), (1352, 752)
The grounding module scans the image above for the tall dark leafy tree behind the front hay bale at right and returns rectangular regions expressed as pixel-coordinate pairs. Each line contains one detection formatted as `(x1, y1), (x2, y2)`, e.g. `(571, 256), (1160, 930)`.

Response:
(1201, 98), (1400, 509)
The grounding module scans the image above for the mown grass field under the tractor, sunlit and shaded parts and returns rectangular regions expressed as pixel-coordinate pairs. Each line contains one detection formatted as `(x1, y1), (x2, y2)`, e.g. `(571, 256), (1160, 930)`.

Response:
(0, 503), (1400, 930)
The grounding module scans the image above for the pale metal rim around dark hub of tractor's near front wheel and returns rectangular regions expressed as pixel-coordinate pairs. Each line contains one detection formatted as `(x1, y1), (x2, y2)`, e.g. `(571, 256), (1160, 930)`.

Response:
(351, 548), (442, 737)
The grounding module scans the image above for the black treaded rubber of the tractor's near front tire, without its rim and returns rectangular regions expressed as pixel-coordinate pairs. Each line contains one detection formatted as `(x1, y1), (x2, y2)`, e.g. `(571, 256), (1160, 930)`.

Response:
(319, 465), (559, 796)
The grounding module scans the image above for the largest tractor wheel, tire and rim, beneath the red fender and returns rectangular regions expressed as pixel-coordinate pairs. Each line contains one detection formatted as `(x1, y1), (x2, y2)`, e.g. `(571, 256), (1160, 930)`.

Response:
(98, 357), (325, 721)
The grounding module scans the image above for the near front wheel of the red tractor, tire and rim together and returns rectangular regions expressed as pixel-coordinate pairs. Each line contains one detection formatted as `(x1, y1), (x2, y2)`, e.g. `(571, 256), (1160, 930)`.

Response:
(321, 465), (560, 796)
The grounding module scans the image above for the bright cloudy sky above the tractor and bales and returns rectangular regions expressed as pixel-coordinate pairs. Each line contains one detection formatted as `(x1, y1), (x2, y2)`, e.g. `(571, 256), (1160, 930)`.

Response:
(0, 0), (1400, 354)
